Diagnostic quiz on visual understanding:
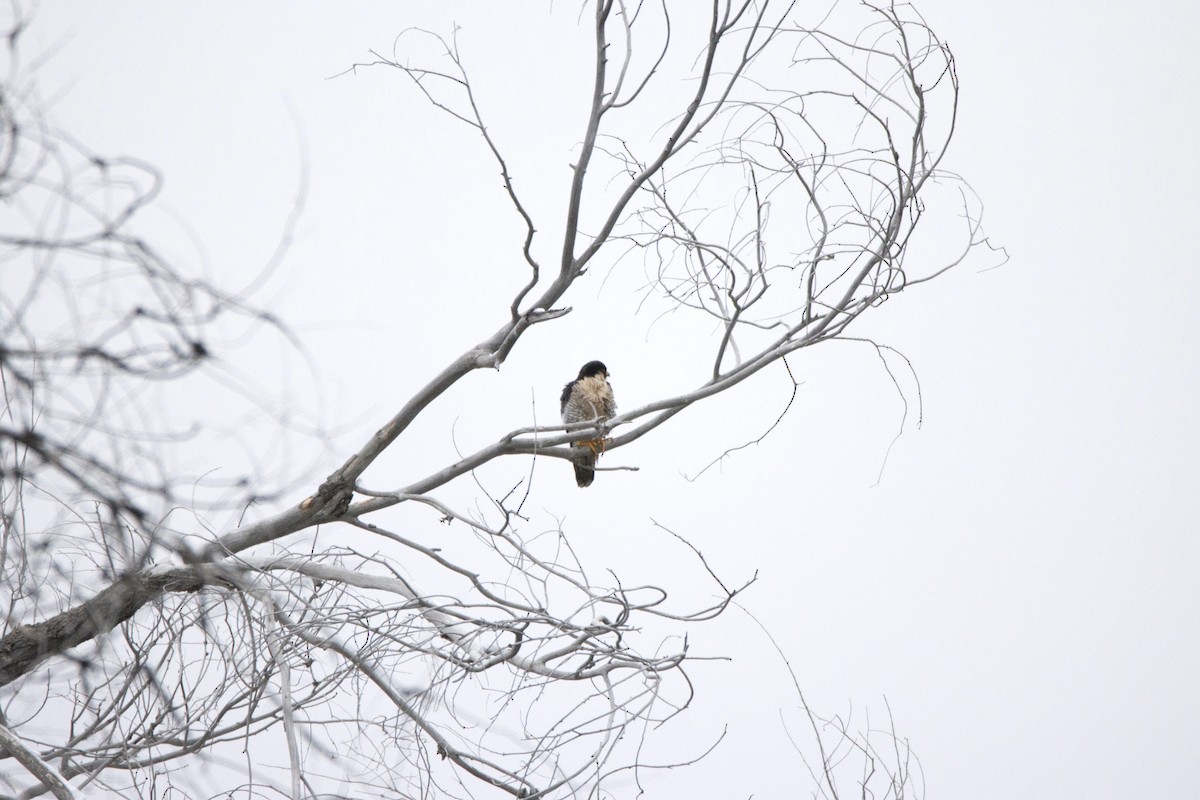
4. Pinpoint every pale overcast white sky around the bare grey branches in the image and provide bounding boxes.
[21,0,1200,800]
